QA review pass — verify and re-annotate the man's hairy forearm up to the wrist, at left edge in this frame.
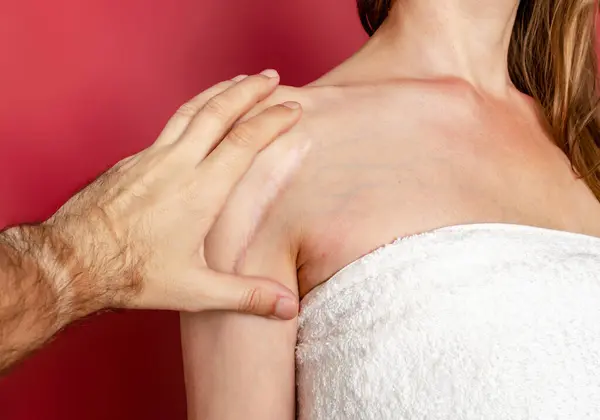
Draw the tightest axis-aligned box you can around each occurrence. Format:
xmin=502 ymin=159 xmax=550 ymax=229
xmin=0 ymin=224 xmax=106 ymax=373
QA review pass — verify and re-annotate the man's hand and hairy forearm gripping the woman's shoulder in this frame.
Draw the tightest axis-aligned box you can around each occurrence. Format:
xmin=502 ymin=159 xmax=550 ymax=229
xmin=0 ymin=71 xmax=306 ymax=370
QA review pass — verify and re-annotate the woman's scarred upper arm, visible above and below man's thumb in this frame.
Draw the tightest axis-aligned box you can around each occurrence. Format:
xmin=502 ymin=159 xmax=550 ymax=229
xmin=181 ymin=96 xmax=306 ymax=420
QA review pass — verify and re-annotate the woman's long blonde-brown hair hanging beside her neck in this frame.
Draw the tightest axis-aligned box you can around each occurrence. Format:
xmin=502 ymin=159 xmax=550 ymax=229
xmin=358 ymin=0 xmax=600 ymax=200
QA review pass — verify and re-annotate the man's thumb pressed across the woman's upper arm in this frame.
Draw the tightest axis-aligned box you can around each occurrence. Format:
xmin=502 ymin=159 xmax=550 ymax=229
xmin=202 ymin=270 xmax=298 ymax=320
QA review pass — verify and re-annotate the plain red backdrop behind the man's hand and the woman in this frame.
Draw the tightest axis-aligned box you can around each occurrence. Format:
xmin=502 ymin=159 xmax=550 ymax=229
xmin=0 ymin=0 xmax=365 ymax=420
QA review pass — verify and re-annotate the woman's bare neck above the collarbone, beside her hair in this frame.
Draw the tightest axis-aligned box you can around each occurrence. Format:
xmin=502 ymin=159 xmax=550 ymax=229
xmin=318 ymin=0 xmax=518 ymax=92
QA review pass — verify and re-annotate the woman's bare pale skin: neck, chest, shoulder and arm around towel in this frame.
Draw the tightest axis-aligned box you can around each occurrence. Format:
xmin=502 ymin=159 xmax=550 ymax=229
xmin=182 ymin=0 xmax=600 ymax=420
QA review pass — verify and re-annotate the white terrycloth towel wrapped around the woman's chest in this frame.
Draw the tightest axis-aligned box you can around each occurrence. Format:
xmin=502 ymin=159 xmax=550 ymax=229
xmin=296 ymin=224 xmax=600 ymax=420
